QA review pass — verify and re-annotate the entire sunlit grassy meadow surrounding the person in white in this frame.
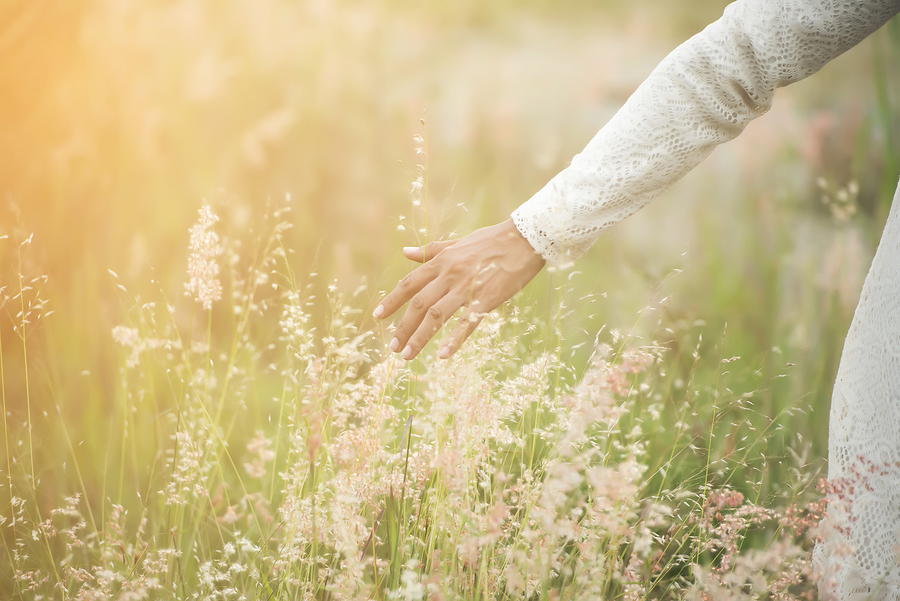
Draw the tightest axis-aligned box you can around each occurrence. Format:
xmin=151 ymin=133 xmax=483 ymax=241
xmin=0 ymin=0 xmax=900 ymax=600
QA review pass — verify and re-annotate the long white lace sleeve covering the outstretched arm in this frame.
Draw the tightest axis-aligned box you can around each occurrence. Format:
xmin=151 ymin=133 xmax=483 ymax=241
xmin=513 ymin=0 xmax=900 ymax=264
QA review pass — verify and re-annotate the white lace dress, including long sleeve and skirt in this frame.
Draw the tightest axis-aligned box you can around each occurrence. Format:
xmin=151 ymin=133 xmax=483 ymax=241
xmin=513 ymin=0 xmax=900 ymax=601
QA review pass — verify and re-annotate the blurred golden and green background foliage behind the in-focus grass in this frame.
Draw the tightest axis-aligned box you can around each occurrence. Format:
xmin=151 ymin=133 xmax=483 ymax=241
xmin=0 ymin=0 xmax=900 ymax=492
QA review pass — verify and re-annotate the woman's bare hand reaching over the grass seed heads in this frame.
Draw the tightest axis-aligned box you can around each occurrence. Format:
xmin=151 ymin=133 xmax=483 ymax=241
xmin=374 ymin=219 xmax=545 ymax=361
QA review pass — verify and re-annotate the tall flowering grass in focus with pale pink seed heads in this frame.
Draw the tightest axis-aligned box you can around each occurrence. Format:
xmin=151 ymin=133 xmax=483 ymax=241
xmin=0 ymin=206 xmax=818 ymax=599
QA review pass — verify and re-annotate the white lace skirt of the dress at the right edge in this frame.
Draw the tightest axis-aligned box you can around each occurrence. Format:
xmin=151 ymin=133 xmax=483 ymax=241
xmin=815 ymin=179 xmax=900 ymax=601
